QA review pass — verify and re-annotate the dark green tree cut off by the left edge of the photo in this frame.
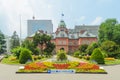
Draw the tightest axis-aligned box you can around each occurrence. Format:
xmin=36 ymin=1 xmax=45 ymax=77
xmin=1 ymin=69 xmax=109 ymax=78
xmin=0 ymin=31 xmax=6 ymax=54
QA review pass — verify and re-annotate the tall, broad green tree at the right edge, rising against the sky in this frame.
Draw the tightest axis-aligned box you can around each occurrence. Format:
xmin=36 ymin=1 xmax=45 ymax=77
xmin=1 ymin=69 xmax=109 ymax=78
xmin=98 ymin=19 xmax=120 ymax=44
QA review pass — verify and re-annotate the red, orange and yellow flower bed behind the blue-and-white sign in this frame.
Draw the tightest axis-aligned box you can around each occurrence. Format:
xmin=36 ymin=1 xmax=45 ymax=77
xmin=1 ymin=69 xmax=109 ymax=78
xmin=18 ymin=62 xmax=105 ymax=73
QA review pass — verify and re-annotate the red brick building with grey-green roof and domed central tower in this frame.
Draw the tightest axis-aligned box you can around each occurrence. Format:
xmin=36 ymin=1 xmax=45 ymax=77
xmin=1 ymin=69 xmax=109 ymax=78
xmin=28 ymin=20 xmax=97 ymax=52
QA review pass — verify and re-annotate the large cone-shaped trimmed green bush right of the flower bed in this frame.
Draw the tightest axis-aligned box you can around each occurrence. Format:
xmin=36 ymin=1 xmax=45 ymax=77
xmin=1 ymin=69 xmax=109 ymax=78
xmin=90 ymin=48 xmax=104 ymax=64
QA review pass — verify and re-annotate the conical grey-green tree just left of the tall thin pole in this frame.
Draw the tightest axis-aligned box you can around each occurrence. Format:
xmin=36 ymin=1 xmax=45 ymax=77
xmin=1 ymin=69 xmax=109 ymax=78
xmin=10 ymin=31 xmax=20 ymax=49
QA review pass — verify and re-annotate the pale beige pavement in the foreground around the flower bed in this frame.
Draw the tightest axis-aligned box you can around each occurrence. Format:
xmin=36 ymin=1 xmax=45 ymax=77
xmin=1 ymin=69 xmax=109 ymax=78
xmin=0 ymin=63 xmax=120 ymax=80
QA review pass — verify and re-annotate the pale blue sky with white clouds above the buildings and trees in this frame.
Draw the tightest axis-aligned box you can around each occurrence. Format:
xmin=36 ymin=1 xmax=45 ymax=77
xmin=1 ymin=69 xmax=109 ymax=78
xmin=0 ymin=0 xmax=120 ymax=38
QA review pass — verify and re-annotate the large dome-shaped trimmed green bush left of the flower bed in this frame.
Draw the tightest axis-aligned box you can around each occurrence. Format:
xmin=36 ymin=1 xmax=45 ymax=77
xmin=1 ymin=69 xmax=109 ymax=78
xmin=19 ymin=48 xmax=33 ymax=64
